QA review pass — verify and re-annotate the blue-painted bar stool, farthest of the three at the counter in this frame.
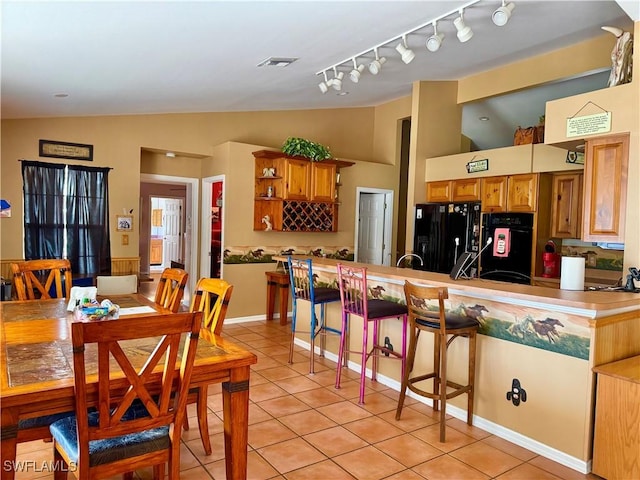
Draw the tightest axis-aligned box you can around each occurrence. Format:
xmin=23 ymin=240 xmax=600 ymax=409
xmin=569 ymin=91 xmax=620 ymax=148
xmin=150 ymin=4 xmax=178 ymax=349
xmin=285 ymin=257 xmax=341 ymax=374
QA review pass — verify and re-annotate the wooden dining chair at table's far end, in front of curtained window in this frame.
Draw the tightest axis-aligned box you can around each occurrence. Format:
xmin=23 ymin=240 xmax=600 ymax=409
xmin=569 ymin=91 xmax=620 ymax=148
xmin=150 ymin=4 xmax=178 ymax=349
xmin=11 ymin=258 xmax=72 ymax=300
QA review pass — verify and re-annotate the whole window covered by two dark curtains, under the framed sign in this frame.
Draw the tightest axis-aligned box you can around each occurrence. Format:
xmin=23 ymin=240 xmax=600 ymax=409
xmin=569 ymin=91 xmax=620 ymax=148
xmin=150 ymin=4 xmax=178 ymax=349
xmin=22 ymin=161 xmax=111 ymax=275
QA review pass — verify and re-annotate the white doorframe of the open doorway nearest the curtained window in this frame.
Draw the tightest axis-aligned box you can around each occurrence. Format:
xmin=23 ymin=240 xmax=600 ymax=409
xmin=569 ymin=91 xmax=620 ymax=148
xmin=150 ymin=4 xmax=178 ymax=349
xmin=140 ymin=173 xmax=200 ymax=305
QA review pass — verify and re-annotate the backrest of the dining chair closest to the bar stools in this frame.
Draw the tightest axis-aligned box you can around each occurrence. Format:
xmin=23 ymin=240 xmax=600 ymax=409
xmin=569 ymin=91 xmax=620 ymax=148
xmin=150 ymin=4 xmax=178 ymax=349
xmin=189 ymin=278 xmax=233 ymax=335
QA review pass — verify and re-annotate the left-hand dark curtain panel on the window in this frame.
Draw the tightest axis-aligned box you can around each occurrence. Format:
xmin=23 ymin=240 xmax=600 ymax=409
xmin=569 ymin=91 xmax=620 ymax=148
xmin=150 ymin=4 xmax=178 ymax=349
xmin=22 ymin=161 xmax=65 ymax=260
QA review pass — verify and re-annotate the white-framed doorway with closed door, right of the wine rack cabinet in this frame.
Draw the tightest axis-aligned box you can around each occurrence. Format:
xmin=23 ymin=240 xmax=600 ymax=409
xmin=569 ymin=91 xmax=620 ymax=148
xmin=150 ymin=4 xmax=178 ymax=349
xmin=355 ymin=187 xmax=393 ymax=266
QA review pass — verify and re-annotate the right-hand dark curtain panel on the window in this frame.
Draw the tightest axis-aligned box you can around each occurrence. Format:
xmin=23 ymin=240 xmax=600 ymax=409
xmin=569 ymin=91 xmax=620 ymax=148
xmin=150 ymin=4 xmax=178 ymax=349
xmin=66 ymin=165 xmax=111 ymax=275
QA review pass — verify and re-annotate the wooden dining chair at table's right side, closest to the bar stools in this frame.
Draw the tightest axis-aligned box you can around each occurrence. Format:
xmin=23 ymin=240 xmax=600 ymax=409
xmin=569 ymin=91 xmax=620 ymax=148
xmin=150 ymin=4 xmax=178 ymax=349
xmin=183 ymin=278 xmax=233 ymax=455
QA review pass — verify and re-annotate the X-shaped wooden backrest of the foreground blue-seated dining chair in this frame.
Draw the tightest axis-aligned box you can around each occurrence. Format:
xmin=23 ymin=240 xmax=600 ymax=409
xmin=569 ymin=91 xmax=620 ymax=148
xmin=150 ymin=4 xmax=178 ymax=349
xmin=71 ymin=312 xmax=202 ymax=444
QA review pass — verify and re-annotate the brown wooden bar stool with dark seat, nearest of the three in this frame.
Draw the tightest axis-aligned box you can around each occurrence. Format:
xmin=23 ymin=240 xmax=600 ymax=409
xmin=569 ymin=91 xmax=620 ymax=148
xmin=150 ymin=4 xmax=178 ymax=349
xmin=396 ymin=281 xmax=478 ymax=443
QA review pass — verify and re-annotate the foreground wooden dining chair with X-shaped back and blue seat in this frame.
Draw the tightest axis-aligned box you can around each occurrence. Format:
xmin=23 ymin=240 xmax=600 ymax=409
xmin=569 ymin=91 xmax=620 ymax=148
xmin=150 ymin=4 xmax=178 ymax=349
xmin=51 ymin=312 xmax=202 ymax=480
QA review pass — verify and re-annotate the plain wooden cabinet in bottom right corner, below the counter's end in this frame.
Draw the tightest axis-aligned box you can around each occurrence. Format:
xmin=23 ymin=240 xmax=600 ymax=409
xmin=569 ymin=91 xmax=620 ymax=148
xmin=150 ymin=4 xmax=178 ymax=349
xmin=592 ymin=356 xmax=640 ymax=479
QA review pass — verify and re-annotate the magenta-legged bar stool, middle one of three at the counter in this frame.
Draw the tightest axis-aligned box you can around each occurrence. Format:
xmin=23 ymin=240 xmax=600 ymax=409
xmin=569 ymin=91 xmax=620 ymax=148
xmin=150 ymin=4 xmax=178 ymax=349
xmin=336 ymin=263 xmax=407 ymax=404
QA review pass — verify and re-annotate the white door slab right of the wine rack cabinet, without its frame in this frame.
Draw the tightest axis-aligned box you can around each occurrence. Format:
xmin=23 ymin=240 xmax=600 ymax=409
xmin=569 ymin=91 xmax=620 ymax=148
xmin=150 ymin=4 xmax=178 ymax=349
xmin=358 ymin=193 xmax=385 ymax=265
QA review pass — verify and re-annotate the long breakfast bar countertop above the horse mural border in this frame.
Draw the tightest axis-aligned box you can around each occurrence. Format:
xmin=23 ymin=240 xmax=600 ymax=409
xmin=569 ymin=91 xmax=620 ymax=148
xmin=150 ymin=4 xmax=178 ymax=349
xmin=273 ymin=255 xmax=640 ymax=318
